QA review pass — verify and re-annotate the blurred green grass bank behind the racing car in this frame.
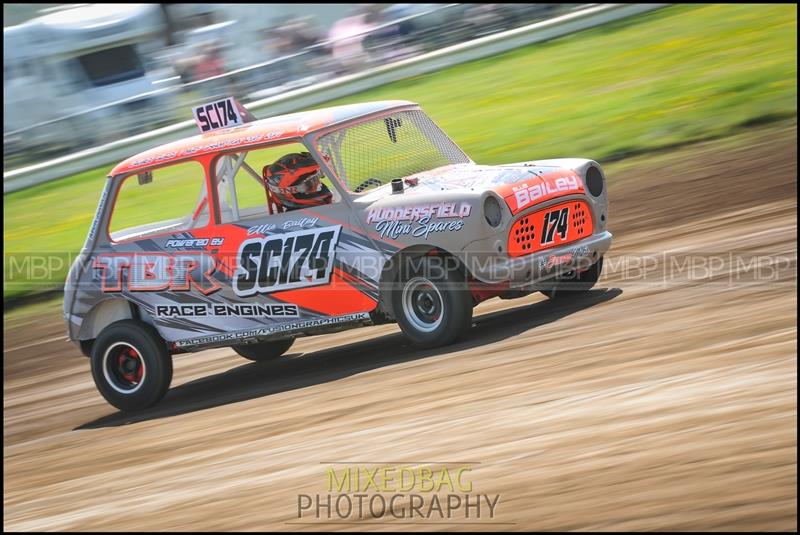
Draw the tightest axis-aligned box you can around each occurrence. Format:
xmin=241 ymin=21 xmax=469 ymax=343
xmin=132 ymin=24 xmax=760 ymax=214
xmin=4 ymin=5 xmax=797 ymax=299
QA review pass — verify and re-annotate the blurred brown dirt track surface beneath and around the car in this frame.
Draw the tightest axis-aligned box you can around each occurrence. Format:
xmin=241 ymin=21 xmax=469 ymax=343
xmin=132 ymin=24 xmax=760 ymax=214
xmin=3 ymin=125 xmax=797 ymax=530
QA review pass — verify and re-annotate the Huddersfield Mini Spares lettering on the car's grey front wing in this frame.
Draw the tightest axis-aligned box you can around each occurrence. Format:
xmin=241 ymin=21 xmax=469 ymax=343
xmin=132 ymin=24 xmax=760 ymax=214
xmin=367 ymin=202 xmax=472 ymax=239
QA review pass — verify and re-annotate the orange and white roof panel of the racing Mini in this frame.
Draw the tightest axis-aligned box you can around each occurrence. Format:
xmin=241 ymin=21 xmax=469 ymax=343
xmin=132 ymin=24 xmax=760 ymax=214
xmin=111 ymin=100 xmax=416 ymax=176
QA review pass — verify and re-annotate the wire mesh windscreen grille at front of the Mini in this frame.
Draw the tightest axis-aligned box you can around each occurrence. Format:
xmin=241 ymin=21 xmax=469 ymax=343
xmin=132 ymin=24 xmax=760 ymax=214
xmin=319 ymin=110 xmax=470 ymax=193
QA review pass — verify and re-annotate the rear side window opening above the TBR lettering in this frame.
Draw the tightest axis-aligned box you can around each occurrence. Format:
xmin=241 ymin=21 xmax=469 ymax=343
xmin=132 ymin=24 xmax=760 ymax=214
xmin=108 ymin=162 xmax=210 ymax=242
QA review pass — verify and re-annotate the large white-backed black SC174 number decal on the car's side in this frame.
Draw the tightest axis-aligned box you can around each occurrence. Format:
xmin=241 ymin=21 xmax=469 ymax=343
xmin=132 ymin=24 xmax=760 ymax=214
xmin=233 ymin=225 xmax=342 ymax=297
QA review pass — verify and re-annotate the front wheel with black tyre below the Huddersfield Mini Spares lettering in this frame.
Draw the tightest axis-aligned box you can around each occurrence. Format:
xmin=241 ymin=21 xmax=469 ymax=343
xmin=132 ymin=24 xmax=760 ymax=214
xmin=391 ymin=256 xmax=472 ymax=348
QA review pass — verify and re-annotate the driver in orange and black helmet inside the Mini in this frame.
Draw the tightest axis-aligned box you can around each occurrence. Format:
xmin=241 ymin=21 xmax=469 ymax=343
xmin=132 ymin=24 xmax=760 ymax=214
xmin=262 ymin=152 xmax=333 ymax=211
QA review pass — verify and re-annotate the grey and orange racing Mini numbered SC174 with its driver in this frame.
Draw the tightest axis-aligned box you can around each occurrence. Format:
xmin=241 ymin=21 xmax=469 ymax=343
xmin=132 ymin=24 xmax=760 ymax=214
xmin=64 ymin=98 xmax=612 ymax=410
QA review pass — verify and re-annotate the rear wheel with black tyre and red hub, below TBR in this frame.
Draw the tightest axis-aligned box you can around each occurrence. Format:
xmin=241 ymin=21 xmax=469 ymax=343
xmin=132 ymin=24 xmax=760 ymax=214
xmin=91 ymin=320 xmax=172 ymax=411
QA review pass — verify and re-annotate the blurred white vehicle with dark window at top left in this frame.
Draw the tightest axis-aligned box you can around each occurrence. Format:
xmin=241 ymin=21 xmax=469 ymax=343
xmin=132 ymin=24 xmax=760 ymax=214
xmin=3 ymin=4 xmax=179 ymax=152
